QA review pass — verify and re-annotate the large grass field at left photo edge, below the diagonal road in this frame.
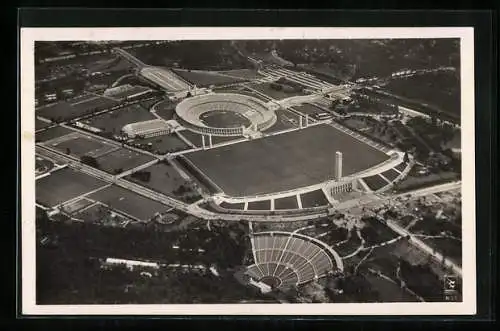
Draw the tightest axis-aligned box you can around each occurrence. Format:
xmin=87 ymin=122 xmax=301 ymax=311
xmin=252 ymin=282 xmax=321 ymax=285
xmin=36 ymin=168 xmax=106 ymax=207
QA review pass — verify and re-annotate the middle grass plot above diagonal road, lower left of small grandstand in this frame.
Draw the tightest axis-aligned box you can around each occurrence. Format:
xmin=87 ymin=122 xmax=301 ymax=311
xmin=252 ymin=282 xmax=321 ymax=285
xmin=97 ymin=148 xmax=153 ymax=174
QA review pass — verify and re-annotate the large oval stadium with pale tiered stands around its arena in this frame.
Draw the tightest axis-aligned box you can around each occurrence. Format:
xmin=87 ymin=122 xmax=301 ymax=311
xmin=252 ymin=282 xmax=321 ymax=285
xmin=175 ymin=93 xmax=277 ymax=136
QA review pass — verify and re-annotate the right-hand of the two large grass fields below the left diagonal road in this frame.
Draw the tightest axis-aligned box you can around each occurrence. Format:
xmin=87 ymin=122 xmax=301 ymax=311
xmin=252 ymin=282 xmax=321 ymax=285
xmin=89 ymin=185 xmax=170 ymax=220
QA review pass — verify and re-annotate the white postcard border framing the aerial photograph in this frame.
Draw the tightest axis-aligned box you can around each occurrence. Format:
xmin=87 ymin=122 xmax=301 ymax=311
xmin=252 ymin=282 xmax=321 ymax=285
xmin=18 ymin=27 xmax=476 ymax=315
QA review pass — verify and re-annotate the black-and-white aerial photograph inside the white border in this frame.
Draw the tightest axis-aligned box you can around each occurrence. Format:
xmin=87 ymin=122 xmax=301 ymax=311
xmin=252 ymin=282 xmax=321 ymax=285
xmin=33 ymin=36 xmax=463 ymax=307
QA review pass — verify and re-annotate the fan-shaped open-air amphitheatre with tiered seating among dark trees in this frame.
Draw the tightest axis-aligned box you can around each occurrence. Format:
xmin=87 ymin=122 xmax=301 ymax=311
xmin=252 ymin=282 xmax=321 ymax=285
xmin=246 ymin=231 xmax=343 ymax=290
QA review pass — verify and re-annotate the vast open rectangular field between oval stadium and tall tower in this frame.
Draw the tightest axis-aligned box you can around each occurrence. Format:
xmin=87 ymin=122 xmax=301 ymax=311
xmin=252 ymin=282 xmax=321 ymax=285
xmin=186 ymin=125 xmax=389 ymax=196
